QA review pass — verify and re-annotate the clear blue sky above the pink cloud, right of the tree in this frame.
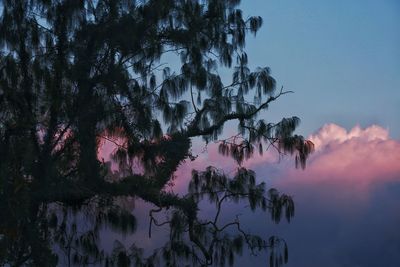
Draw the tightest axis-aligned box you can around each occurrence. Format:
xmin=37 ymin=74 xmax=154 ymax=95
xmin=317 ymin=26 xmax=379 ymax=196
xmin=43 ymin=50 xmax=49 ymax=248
xmin=242 ymin=0 xmax=400 ymax=139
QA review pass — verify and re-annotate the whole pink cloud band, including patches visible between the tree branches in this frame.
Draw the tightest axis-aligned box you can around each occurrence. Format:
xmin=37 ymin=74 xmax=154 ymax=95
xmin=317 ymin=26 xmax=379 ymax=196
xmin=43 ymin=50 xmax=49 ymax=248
xmin=101 ymin=123 xmax=400 ymax=201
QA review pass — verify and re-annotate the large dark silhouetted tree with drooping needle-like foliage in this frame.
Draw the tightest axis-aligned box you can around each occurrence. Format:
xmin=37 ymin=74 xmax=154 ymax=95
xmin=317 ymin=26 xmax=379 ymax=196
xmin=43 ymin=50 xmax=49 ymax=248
xmin=0 ymin=0 xmax=313 ymax=266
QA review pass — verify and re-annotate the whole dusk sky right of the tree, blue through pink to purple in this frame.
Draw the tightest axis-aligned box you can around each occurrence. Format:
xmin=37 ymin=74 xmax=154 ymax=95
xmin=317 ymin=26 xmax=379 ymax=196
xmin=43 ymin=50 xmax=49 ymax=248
xmin=101 ymin=0 xmax=400 ymax=267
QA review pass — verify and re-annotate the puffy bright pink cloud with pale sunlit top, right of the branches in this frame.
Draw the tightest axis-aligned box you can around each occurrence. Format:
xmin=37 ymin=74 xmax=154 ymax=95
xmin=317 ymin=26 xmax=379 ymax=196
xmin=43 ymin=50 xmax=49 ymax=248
xmin=281 ymin=124 xmax=400 ymax=194
